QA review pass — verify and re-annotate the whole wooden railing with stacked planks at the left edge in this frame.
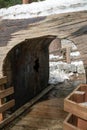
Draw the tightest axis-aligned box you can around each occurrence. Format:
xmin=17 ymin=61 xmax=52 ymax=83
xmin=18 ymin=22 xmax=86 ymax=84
xmin=0 ymin=77 xmax=15 ymax=122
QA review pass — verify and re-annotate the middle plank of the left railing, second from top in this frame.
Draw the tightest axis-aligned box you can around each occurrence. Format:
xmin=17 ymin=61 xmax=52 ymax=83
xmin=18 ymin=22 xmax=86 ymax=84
xmin=0 ymin=87 xmax=14 ymax=99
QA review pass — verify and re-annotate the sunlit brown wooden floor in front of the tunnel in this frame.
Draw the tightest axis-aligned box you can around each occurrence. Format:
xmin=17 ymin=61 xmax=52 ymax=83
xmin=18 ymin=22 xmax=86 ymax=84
xmin=6 ymin=98 xmax=67 ymax=130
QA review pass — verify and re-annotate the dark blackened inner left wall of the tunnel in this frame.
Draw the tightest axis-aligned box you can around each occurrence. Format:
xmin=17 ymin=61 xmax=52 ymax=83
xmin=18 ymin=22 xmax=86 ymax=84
xmin=3 ymin=36 xmax=55 ymax=111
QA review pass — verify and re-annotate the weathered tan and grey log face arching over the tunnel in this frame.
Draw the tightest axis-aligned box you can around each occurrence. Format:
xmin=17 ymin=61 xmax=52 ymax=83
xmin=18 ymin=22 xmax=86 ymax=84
xmin=0 ymin=11 xmax=87 ymax=76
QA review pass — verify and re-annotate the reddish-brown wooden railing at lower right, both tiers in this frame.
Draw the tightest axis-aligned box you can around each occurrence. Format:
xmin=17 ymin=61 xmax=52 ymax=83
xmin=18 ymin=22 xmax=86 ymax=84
xmin=64 ymin=84 xmax=87 ymax=130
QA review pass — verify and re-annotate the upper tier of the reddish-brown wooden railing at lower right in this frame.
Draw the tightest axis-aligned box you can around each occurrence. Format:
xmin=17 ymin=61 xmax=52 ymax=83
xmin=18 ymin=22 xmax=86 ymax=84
xmin=64 ymin=84 xmax=87 ymax=121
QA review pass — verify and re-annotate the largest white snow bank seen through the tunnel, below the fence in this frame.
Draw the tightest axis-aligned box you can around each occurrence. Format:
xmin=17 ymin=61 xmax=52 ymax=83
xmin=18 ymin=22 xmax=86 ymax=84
xmin=49 ymin=56 xmax=85 ymax=84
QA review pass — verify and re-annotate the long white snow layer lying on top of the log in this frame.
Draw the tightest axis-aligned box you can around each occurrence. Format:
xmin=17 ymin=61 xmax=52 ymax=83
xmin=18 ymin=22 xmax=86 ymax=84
xmin=0 ymin=0 xmax=87 ymax=19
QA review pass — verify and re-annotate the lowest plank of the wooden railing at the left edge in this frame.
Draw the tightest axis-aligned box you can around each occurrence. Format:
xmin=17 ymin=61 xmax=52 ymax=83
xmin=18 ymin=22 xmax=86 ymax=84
xmin=0 ymin=99 xmax=15 ymax=113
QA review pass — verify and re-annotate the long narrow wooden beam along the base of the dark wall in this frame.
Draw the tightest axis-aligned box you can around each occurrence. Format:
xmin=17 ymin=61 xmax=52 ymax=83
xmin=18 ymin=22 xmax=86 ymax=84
xmin=0 ymin=85 xmax=54 ymax=129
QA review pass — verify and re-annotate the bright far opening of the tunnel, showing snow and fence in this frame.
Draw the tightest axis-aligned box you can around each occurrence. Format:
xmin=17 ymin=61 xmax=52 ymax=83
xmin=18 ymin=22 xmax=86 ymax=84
xmin=49 ymin=39 xmax=86 ymax=97
